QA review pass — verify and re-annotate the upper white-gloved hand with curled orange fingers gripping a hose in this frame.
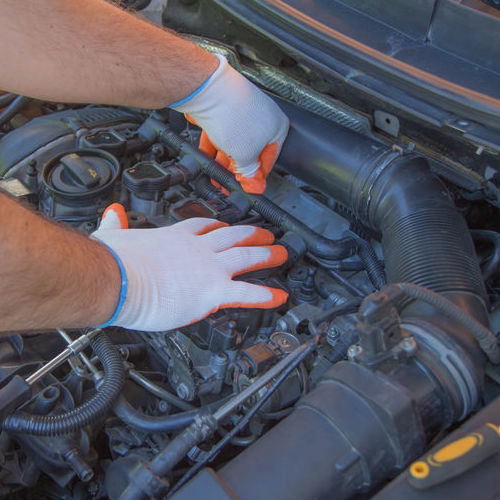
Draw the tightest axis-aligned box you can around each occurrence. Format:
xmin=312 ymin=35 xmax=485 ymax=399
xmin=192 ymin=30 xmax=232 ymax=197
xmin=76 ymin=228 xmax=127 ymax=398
xmin=170 ymin=55 xmax=288 ymax=194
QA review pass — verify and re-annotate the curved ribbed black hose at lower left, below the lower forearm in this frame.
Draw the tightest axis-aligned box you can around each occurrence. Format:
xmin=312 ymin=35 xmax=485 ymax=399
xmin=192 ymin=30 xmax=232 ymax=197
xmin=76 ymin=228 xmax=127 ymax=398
xmin=2 ymin=333 xmax=125 ymax=436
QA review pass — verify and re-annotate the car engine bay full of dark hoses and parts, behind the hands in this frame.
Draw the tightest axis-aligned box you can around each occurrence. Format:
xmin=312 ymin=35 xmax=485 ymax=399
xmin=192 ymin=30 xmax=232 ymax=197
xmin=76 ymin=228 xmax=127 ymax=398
xmin=0 ymin=2 xmax=500 ymax=500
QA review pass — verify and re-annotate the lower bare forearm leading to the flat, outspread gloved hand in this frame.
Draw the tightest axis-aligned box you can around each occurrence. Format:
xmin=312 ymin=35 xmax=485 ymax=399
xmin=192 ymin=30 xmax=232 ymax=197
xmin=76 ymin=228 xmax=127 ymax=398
xmin=0 ymin=193 xmax=120 ymax=331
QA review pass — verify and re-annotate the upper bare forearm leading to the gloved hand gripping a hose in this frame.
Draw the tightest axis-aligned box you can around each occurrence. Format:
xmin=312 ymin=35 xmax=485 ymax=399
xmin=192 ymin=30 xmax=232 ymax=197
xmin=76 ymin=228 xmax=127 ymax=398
xmin=0 ymin=0 xmax=217 ymax=108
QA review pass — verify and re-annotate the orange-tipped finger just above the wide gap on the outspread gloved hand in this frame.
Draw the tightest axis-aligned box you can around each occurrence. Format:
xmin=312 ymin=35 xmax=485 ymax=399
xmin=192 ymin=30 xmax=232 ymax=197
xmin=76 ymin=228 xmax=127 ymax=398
xmin=218 ymin=245 xmax=288 ymax=278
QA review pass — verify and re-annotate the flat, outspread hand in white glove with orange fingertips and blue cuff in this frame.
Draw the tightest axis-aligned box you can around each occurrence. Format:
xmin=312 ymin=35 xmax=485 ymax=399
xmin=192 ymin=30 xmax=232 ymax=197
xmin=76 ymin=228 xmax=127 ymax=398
xmin=92 ymin=203 xmax=288 ymax=331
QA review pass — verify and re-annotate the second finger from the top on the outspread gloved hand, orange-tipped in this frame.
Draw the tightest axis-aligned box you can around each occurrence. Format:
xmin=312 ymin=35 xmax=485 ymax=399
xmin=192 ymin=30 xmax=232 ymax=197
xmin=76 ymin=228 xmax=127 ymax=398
xmin=203 ymin=226 xmax=274 ymax=252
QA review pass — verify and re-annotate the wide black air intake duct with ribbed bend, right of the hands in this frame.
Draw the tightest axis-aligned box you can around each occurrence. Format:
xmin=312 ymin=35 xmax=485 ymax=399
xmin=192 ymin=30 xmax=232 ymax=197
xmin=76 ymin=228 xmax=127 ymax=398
xmin=280 ymin=102 xmax=486 ymax=322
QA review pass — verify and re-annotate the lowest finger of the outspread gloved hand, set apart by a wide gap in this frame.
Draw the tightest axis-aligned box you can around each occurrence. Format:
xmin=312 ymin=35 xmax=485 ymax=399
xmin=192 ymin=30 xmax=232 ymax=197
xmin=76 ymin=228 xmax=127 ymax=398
xmin=218 ymin=281 xmax=288 ymax=309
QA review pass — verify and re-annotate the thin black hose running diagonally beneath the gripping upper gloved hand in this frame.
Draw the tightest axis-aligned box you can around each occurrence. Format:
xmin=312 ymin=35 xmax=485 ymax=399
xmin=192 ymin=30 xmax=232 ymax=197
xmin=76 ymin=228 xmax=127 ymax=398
xmin=156 ymin=123 xmax=357 ymax=260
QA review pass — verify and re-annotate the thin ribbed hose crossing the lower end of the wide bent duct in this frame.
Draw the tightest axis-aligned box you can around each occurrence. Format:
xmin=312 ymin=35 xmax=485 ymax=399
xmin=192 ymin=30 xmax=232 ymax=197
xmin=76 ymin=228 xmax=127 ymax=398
xmin=387 ymin=283 xmax=500 ymax=364
